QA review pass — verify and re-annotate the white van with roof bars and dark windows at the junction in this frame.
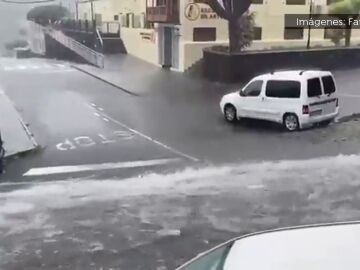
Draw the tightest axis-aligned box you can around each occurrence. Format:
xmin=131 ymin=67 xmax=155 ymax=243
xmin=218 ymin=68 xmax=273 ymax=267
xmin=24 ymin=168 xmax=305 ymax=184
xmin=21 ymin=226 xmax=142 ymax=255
xmin=220 ymin=70 xmax=339 ymax=131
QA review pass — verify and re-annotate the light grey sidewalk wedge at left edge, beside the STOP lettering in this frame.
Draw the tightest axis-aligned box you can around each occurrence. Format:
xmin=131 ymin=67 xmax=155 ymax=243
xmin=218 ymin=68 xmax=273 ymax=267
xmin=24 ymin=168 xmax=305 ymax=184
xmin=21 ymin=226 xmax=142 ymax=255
xmin=0 ymin=89 xmax=38 ymax=157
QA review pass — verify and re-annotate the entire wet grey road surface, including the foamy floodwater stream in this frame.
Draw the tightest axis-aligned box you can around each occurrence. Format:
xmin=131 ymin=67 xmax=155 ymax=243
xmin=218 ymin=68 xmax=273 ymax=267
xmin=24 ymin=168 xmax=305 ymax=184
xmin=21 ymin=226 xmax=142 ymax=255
xmin=0 ymin=60 xmax=360 ymax=270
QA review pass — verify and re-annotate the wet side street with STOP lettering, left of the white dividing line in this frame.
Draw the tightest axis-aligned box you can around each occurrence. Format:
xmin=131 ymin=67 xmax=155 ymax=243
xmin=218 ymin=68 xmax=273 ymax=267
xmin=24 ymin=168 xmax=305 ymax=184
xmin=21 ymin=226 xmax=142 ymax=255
xmin=1 ymin=60 xmax=197 ymax=181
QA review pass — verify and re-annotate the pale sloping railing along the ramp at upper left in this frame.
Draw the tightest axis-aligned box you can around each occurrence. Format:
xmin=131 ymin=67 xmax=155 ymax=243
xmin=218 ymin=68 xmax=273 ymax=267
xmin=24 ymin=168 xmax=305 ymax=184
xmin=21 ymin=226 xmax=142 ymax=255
xmin=46 ymin=27 xmax=104 ymax=68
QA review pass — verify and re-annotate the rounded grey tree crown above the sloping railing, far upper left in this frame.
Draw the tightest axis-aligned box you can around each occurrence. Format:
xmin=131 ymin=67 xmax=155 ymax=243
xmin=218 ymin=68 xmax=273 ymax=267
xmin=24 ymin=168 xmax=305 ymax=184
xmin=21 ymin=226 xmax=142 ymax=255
xmin=26 ymin=5 xmax=70 ymax=25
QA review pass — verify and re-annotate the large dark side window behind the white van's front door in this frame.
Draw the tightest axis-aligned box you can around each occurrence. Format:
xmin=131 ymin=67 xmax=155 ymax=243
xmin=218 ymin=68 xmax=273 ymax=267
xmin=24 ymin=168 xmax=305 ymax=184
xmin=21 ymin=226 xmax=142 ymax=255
xmin=266 ymin=80 xmax=301 ymax=98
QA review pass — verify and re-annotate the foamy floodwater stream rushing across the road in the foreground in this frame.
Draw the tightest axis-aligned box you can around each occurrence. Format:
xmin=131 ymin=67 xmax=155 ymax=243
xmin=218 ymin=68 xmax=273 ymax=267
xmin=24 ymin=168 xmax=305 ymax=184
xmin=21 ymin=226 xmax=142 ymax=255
xmin=0 ymin=156 xmax=360 ymax=270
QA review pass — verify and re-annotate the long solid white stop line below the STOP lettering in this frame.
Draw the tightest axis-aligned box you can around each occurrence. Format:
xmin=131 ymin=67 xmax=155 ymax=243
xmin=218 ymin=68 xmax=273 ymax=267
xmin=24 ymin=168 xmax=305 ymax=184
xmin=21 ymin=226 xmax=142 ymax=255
xmin=24 ymin=158 xmax=181 ymax=176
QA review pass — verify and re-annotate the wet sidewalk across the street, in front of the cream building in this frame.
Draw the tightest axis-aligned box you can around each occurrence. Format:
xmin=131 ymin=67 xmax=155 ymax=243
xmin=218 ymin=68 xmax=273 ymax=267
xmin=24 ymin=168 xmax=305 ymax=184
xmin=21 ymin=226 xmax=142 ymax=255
xmin=73 ymin=54 xmax=238 ymax=96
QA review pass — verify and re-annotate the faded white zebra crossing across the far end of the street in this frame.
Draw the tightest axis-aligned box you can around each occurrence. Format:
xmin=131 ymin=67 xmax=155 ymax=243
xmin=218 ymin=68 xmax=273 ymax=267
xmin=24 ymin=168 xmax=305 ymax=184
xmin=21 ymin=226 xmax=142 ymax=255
xmin=0 ymin=60 xmax=74 ymax=73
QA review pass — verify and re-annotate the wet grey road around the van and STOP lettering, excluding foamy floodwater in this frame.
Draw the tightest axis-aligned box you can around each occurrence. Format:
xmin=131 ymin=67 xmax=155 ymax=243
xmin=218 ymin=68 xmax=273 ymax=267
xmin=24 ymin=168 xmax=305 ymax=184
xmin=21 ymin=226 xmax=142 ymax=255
xmin=0 ymin=59 xmax=360 ymax=180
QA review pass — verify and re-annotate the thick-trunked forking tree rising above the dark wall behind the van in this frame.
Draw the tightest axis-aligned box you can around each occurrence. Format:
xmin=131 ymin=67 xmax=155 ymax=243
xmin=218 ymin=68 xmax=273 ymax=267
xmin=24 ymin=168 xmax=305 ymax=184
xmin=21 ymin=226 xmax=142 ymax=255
xmin=205 ymin=0 xmax=251 ymax=53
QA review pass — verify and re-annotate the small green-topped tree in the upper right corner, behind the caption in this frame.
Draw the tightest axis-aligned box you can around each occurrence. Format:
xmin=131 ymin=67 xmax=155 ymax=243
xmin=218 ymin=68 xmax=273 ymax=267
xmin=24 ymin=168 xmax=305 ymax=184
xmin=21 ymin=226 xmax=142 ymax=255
xmin=329 ymin=0 xmax=360 ymax=46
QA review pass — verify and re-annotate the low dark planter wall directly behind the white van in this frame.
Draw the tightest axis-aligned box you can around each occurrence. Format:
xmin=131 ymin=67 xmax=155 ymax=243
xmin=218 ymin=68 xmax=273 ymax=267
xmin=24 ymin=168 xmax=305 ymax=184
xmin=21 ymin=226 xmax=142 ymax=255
xmin=203 ymin=48 xmax=360 ymax=82
